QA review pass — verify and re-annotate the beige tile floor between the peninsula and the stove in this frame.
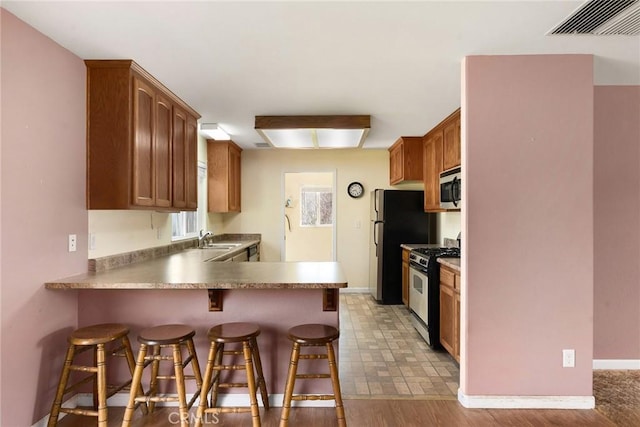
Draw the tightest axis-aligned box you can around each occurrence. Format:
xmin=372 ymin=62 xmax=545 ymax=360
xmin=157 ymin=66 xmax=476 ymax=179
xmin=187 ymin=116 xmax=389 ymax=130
xmin=339 ymin=294 xmax=460 ymax=399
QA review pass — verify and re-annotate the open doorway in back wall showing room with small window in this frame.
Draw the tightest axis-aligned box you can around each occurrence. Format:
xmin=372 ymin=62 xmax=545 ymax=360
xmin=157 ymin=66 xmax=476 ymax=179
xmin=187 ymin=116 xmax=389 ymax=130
xmin=281 ymin=172 xmax=336 ymax=261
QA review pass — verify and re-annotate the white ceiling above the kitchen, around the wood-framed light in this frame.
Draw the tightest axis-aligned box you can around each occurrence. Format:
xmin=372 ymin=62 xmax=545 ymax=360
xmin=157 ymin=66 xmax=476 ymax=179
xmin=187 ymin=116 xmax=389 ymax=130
xmin=2 ymin=0 xmax=640 ymax=148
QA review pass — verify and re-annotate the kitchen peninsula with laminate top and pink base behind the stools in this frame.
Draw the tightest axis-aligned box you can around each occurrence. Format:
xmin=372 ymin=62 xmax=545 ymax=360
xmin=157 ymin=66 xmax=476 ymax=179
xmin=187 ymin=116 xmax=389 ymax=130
xmin=45 ymin=248 xmax=347 ymax=406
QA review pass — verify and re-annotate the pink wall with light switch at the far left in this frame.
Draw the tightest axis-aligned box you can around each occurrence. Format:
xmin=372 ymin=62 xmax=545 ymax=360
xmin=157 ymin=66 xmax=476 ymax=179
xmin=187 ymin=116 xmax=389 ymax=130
xmin=0 ymin=9 xmax=87 ymax=426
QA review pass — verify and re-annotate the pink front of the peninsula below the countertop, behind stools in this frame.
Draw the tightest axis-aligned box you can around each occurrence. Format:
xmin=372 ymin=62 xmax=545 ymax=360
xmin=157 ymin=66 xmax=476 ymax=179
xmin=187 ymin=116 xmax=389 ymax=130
xmin=78 ymin=289 xmax=339 ymax=396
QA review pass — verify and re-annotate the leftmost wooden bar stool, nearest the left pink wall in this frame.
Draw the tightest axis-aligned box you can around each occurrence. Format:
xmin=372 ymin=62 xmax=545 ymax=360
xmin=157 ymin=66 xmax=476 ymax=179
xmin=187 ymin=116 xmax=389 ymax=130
xmin=47 ymin=323 xmax=147 ymax=427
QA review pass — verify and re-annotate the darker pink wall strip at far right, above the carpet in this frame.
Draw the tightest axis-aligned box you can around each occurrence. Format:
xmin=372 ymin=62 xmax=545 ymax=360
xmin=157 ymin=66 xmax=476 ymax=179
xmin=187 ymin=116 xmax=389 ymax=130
xmin=593 ymin=86 xmax=640 ymax=360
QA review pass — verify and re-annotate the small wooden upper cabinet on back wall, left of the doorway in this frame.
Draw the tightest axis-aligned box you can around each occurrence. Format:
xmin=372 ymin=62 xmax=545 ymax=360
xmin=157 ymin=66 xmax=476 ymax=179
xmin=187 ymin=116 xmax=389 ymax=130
xmin=207 ymin=140 xmax=242 ymax=212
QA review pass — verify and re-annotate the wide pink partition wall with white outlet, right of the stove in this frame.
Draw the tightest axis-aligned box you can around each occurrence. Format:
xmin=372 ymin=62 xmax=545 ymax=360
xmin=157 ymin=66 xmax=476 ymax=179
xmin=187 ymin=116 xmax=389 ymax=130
xmin=461 ymin=55 xmax=593 ymax=396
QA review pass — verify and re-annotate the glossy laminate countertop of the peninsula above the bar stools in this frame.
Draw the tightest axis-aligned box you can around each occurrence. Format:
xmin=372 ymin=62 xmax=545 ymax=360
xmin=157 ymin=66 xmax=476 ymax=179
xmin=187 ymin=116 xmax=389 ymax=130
xmin=45 ymin=249 xmax=347 ymax=289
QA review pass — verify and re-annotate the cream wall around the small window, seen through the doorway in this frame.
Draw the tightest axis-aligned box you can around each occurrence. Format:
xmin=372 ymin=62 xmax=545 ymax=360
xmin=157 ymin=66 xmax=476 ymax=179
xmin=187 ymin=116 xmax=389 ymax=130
xmin=280 ymin=172 xmax=333 ymax=261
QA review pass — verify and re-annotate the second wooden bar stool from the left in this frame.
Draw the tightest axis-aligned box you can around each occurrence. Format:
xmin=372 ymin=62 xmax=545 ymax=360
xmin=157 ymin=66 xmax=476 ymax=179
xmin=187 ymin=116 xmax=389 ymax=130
xmin=122 ymin=325 xmax=202 ymax=427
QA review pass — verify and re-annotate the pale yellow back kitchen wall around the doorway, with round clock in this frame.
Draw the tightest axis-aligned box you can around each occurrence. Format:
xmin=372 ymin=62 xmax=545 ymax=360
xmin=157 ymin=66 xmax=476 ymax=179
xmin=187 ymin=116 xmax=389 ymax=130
xmin=216 ymin=150 xmax=389 ymax=287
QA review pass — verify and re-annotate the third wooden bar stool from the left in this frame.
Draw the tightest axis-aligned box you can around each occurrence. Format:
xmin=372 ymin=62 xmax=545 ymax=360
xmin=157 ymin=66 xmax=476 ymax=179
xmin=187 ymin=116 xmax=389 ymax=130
xmin=195 ymin=322 xmax=269 ymax=427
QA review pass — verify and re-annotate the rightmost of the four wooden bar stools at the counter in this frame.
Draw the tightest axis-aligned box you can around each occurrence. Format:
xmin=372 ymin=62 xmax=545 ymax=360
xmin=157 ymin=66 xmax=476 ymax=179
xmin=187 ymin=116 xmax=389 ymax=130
xmin=280 ymin=324 xmax=347 ymax=427
